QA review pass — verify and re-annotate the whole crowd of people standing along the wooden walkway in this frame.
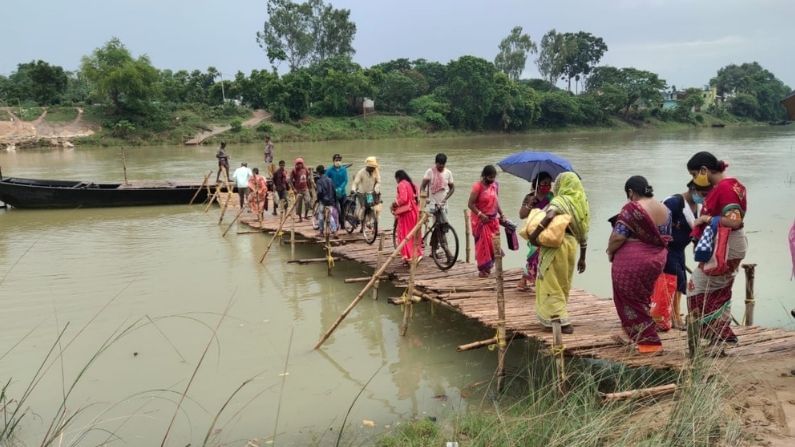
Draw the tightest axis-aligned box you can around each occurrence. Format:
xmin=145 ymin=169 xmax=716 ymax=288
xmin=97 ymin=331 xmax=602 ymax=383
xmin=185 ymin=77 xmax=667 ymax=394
xmin=216 ymin=139 xmax=747 ymax=354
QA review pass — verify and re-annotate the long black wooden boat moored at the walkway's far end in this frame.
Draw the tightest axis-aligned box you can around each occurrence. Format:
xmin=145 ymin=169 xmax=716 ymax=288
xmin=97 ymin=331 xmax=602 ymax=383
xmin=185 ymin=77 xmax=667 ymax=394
xmin=0 ymin=177 xmax=222 ymax=208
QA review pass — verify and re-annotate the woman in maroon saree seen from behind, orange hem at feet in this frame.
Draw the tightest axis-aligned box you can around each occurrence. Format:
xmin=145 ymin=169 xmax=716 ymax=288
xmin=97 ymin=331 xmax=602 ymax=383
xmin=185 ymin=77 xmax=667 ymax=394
xmin=607 ymin=175 xmax=671 ymax=353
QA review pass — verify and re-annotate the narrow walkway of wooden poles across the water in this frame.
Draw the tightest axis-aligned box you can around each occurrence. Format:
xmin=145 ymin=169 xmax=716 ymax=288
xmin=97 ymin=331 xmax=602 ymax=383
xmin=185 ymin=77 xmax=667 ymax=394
xmin=218 ymin=195 xmax=795 ymax=369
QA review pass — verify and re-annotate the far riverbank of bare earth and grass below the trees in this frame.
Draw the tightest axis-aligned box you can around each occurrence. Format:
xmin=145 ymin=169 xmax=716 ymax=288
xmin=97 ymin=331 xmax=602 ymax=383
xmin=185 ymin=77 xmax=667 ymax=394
xmin=0 ymin=106 xmax=766 ymax=149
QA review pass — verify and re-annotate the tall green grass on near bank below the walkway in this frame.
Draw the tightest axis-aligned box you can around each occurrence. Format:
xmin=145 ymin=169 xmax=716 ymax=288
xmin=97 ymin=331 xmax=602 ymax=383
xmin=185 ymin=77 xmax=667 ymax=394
xmin=378 ymin=342 xmax=742 ymax=447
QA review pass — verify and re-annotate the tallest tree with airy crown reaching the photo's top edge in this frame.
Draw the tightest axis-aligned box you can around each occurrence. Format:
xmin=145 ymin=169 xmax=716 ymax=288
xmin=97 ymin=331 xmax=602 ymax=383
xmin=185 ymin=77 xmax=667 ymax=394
xmin=257 ymin=0 xmax=356 ymax=71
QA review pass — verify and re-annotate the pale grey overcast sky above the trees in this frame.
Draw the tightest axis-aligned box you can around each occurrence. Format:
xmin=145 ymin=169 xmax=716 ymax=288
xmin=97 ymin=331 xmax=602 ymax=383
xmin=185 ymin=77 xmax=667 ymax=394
xmin=0 ymin=0 xmax=795 ymax=88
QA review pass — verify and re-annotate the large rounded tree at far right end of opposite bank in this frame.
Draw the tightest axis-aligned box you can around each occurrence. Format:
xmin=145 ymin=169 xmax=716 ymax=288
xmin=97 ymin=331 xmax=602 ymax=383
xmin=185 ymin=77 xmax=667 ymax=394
xmin=710 ymin=62 xmax=790 ymax=120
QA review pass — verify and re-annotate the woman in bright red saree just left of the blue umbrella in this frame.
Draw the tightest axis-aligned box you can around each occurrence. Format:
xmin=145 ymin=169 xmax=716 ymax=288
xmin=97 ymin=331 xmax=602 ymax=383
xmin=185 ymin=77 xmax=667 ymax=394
xmin=468 ymin=165 xmax=503 ymax=278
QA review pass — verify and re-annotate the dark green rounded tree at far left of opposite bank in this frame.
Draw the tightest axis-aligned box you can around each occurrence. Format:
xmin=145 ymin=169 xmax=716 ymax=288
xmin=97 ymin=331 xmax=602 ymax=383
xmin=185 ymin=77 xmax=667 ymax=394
xmin=8 ymin=60 xmax=68 ymax=105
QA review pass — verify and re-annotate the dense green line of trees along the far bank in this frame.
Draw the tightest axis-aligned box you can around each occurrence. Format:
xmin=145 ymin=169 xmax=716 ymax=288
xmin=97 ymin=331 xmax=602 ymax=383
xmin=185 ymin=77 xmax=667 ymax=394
xmin=0 ymin=21 xmax=789 ymax=138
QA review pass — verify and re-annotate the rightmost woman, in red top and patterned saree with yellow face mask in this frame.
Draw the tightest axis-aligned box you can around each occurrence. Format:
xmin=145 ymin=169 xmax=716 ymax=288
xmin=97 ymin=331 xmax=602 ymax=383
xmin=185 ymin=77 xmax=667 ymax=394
xmin=687 ymin=152 xmax=748 ymax=345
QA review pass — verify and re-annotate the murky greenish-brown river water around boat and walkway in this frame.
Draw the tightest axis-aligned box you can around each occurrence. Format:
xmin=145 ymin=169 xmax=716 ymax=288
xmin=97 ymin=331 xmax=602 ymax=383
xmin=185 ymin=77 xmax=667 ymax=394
xmin=0 ymin=127 xmax=795 ymax=445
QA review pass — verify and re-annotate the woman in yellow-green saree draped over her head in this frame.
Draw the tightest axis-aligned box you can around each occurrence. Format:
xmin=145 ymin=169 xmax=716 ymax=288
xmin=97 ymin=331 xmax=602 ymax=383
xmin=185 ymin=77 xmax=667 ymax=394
xmin=528 ymin=172 xmax=591 ymax=334
